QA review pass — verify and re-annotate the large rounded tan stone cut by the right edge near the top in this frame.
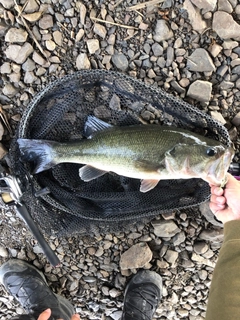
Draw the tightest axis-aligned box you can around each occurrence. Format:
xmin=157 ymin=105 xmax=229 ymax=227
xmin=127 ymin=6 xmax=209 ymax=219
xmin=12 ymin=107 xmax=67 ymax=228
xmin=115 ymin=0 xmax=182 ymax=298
xmin=212 ymin=11 xmax=240 ymax=41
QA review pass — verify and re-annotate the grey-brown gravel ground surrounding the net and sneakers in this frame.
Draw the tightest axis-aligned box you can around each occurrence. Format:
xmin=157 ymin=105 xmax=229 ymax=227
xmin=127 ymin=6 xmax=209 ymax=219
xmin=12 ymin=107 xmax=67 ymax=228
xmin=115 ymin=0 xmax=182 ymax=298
xmin=0 ymin=0 xmax=240 ymax=320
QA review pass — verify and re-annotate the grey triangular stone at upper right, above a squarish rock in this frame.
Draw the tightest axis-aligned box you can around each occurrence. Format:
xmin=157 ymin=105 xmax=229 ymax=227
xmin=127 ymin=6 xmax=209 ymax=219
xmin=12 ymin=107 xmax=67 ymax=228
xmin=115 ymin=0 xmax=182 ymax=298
xmin=187 ymin=48 xmax=216 ymax=72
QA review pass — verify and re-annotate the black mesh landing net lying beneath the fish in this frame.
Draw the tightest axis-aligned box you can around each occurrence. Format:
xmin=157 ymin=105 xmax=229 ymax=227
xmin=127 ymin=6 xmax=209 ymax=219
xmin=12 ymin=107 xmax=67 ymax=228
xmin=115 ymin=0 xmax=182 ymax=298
xmin=10 ymin=70 xmax=231 ymax=236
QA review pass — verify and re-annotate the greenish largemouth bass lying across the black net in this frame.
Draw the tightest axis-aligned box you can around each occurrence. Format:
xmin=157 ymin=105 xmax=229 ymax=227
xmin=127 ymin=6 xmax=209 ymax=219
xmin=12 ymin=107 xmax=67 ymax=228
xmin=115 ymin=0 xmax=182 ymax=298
xmin=18 ymin=116 xmax=234 ymax=192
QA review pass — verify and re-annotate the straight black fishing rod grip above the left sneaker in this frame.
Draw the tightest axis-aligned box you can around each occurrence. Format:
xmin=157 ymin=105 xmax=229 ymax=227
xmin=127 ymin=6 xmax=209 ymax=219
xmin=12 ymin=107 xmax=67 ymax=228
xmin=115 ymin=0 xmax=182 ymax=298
xmin=16 ymin=205 xmax=60 ymax=267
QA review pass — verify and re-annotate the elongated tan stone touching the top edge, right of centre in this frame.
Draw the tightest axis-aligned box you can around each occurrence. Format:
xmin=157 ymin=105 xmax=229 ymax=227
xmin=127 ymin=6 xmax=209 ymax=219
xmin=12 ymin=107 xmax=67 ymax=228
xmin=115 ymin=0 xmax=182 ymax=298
xmin=183 ymin=0 xmax=207 ymax=32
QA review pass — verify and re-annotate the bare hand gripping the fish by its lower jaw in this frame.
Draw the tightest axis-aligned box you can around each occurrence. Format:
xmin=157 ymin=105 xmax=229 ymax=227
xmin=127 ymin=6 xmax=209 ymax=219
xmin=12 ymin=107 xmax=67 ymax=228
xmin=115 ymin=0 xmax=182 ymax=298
xmin=209 ymin=173 xmax=240 ymax=223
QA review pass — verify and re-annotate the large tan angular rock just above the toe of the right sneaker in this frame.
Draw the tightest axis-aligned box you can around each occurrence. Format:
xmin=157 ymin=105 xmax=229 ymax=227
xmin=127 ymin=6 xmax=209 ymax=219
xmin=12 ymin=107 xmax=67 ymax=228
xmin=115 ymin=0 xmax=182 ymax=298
xmin=120 ymin=242 xmax=152 ymax=270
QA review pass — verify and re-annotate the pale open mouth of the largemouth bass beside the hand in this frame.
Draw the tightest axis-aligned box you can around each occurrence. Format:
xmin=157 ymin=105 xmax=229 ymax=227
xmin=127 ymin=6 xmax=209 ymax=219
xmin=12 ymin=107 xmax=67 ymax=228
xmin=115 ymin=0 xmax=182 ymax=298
xmin=207 ymin=147 xmax=234 ymax=186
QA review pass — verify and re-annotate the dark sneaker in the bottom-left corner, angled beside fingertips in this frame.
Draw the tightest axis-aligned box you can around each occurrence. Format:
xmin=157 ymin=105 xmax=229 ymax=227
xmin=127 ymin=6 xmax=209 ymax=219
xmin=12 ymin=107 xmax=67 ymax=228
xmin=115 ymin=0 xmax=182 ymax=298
xmin=0 ymin=259 xmax=74 ymax=320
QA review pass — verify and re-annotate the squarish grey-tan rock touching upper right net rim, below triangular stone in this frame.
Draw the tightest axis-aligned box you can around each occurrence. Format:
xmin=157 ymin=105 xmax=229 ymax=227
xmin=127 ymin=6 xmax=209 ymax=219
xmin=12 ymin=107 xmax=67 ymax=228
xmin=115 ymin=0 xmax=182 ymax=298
xmin=187 ymin=80 xmax=212 ymax=102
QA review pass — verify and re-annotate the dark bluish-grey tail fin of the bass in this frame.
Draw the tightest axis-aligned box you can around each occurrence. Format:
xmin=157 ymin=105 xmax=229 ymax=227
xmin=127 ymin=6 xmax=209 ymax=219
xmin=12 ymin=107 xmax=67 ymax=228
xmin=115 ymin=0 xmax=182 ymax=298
xmin=17 ymin=139 xmax=56 ymax=174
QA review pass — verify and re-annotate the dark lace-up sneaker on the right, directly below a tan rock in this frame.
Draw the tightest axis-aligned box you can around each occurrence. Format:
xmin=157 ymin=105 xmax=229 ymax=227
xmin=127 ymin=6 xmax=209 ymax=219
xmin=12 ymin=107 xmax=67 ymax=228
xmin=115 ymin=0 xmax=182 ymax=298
xmin=122 ymin=270 xmax=162 ymax=320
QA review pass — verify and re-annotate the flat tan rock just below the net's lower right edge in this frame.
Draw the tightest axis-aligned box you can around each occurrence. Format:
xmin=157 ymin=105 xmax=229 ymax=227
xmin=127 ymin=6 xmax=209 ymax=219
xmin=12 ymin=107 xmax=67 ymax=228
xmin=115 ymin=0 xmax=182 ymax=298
xmin=152 ymin=220 xmax=180 ymax=238
